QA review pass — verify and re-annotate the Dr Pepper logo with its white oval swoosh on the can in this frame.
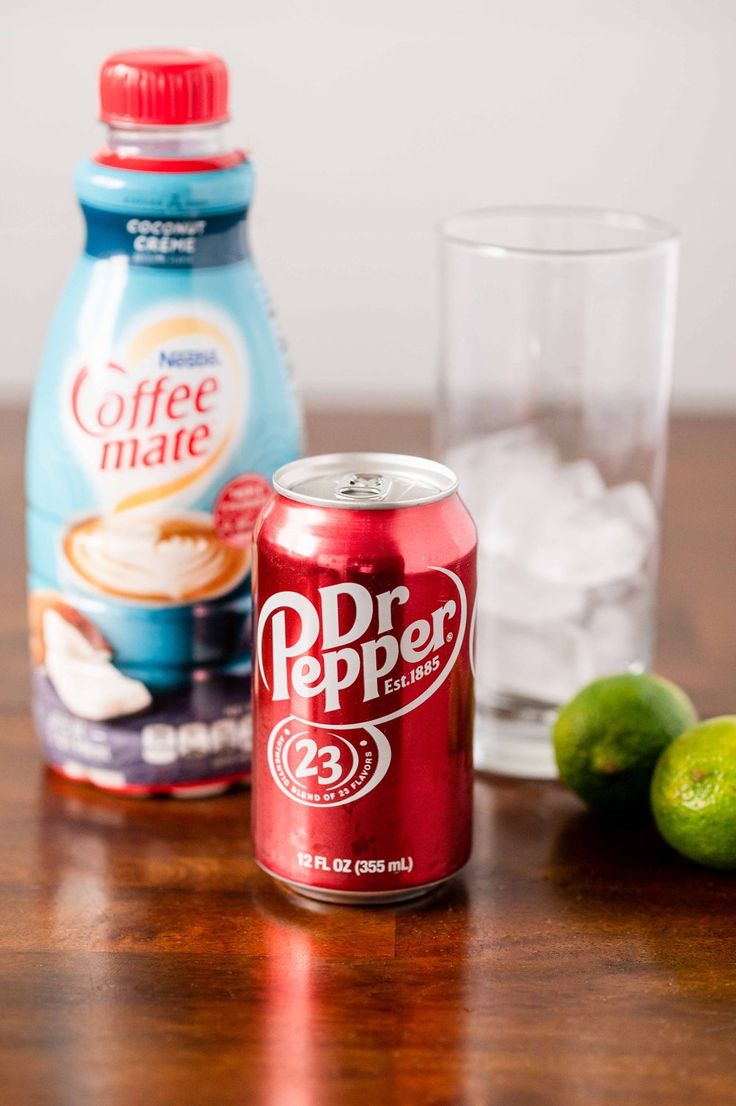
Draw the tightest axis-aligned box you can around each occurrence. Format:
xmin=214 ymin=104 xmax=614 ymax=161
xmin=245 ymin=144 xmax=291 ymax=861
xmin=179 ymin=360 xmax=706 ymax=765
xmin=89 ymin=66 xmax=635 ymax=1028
xmin=257 ymin=567 xmax=467 ymax=729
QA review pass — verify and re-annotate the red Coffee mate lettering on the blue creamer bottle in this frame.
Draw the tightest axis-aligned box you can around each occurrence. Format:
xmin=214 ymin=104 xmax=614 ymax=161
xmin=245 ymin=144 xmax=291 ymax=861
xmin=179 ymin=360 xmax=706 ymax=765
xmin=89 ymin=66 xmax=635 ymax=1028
xmin=71 ymin=354 xmax=220 ymax=471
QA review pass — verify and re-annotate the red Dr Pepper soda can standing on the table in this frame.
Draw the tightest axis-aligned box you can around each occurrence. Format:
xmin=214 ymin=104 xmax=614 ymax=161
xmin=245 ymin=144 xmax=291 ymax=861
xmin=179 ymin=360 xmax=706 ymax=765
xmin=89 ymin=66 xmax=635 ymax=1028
xmin=252 ymin=453 xmax=476 ymax=904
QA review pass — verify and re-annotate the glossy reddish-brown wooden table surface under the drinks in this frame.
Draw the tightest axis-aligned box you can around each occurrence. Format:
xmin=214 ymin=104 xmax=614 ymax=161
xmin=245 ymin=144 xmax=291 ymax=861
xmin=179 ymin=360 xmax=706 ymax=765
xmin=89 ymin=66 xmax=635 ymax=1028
xmin=0 ymin=411 xmax=736 ymax=1106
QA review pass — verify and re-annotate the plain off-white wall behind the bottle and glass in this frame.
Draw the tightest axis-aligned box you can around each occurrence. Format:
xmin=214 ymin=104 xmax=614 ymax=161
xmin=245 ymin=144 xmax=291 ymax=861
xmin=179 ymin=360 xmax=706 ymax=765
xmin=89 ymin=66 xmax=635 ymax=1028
xmin=0 ymin=0 xmax=736 ymax=408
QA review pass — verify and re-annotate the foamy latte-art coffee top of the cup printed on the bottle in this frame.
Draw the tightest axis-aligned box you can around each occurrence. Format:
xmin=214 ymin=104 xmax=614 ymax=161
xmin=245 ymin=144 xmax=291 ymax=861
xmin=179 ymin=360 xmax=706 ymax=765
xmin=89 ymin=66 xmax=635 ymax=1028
xmin=58 ymin=510 xmax=250 ymax=607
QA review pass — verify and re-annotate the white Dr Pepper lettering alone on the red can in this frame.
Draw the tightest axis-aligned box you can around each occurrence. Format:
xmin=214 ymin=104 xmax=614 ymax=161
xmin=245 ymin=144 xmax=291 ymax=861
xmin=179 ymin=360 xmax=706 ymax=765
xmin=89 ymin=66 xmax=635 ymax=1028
xmin=258 ymin=583 xmax=458 ymax=711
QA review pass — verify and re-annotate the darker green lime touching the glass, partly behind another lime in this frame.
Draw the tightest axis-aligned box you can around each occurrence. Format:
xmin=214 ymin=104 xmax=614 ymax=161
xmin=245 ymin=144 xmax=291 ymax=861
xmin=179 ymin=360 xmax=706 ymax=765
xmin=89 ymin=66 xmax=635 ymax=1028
xmin=552 ymin=674 xmax=697 ymax=812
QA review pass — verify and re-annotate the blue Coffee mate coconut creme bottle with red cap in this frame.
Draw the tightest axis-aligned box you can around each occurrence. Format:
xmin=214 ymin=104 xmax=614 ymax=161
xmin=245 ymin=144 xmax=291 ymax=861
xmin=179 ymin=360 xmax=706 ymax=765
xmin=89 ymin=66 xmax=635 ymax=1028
xmin=27 ymin=51 xmax=299 ymax=796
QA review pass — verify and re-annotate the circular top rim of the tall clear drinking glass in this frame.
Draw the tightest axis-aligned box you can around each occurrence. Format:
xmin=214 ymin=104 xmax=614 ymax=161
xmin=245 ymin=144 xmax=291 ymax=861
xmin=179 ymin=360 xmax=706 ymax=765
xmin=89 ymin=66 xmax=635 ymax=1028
xmin=437 ymin=204 xmax=680 ymax=258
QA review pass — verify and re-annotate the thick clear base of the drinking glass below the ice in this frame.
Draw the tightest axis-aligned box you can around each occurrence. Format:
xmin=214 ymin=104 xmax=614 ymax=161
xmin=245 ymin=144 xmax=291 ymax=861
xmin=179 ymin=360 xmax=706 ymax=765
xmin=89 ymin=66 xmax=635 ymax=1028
xmin=474 ymin=703 xmax=557 ymax=780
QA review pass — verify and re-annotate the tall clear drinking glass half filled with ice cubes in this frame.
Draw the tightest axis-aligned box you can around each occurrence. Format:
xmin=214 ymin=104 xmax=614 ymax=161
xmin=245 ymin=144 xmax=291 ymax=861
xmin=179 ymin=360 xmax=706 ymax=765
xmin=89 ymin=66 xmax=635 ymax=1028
xmin=436 ymin=207 xmax=678 ymax=778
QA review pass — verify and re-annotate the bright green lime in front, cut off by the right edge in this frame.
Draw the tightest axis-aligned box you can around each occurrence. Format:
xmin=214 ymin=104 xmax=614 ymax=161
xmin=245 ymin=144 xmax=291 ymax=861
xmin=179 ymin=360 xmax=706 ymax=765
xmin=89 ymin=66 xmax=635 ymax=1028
xmin=652 ymin=714 xmax=736 ymax=868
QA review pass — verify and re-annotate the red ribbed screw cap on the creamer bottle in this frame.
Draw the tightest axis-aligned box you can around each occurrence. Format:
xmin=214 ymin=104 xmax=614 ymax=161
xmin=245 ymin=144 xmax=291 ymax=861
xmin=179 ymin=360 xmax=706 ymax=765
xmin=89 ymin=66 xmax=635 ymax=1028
xmin=100 ymin=50 xmax=228 ymax=126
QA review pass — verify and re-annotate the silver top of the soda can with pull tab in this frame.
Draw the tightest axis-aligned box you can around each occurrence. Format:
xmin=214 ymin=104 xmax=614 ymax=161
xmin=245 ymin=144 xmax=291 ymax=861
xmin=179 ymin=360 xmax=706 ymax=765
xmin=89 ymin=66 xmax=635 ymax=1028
xmin=273 ymin=453 xmax=457 ymax=511
